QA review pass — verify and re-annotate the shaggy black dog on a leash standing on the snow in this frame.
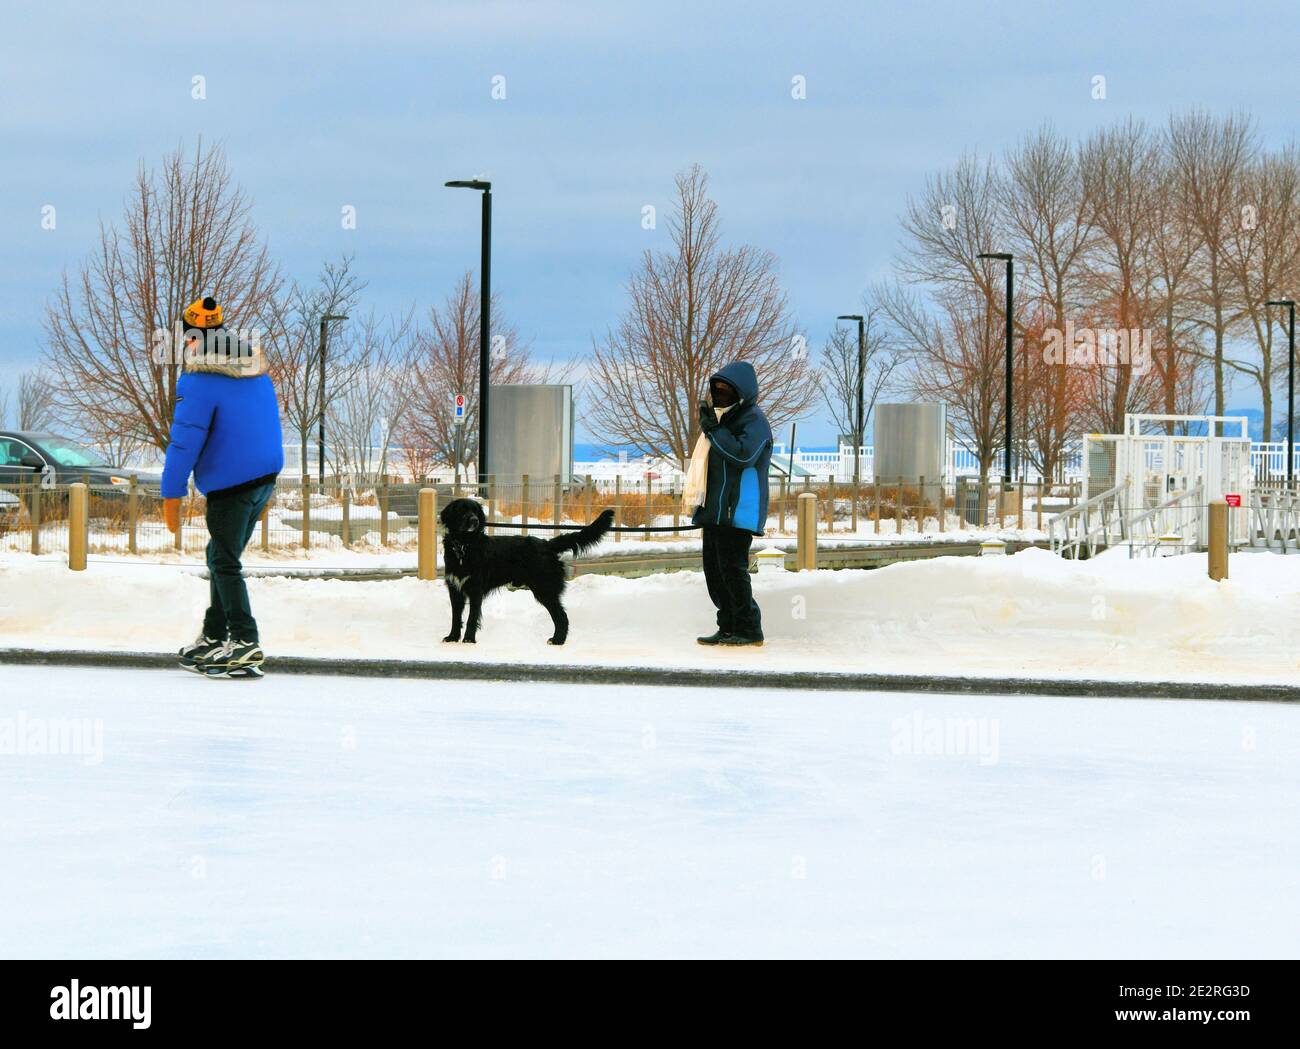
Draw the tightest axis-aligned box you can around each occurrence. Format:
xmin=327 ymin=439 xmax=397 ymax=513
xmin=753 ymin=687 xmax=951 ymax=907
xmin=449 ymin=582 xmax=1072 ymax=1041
xmin=438 ymin=499 xmax=614 ymax=645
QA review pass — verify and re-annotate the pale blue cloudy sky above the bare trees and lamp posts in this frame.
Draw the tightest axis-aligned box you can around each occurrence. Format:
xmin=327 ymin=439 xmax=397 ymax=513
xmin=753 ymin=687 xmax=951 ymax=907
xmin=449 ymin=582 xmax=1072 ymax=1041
xmin=0 ymin=0 xmax=1300 ymax=443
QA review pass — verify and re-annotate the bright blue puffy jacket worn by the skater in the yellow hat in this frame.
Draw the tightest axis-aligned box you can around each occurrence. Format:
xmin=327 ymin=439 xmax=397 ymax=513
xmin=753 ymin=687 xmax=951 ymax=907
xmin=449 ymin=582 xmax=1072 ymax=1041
xmin=163 ymin=354 xmax=285 ymax=499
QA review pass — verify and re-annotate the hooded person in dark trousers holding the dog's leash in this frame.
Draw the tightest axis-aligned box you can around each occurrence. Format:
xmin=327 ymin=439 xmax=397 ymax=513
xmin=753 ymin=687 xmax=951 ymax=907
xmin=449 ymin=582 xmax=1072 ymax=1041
xmin=692 ymin=360 xmax=772 ymax=645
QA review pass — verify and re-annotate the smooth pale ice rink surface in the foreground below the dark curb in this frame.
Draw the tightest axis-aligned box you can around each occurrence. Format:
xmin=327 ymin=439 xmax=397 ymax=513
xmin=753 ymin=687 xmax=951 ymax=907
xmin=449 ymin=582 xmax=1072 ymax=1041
xmin=0 ymin=667 xmax=1300 ymax=957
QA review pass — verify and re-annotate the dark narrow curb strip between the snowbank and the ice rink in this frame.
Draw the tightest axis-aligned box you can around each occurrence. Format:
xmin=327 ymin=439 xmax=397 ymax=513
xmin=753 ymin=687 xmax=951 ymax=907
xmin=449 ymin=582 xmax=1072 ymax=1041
xmin=0 ymin=649 xmax=1300 ymax=703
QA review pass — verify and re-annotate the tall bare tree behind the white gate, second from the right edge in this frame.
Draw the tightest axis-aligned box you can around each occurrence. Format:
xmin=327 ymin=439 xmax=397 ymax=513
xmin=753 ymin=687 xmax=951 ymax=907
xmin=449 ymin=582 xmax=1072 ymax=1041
xmin=1165 ymin=110 xmax=1258 ymax=415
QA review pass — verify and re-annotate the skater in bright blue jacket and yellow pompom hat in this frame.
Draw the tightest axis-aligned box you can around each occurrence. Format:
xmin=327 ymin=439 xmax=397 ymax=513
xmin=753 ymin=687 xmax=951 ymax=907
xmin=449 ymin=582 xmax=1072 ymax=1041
xmin=163 ymin=298 xmax=285 ymax=677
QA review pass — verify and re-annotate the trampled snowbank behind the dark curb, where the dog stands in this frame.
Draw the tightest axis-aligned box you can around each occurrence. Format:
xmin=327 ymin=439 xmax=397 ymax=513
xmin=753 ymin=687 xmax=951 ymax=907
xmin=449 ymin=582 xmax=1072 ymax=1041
xmin=0 ymin=543 xmax=1300 ymax=684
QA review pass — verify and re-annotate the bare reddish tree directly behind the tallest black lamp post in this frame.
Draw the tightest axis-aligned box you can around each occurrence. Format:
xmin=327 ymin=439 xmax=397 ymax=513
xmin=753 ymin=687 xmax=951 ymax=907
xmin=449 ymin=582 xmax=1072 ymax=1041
xmin=399 ymin=272 xmax=551 ymax=480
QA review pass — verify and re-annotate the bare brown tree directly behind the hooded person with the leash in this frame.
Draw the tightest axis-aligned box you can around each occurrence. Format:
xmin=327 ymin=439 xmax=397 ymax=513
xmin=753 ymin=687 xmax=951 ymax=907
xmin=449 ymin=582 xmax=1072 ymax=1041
xmin=586 ymin=164 xmax=818 ymax=463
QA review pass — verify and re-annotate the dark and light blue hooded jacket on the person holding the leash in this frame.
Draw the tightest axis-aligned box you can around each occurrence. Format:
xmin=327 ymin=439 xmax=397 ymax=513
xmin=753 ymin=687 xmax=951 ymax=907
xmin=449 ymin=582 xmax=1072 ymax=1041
xmin=692 ymin=360 xmax=772 ymax=536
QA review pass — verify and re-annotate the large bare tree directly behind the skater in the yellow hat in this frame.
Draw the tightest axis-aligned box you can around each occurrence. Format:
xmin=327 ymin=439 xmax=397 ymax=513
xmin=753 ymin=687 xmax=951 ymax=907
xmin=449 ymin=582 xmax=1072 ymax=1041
xmin=43 ymin=142 xmax=280 ymax=450
